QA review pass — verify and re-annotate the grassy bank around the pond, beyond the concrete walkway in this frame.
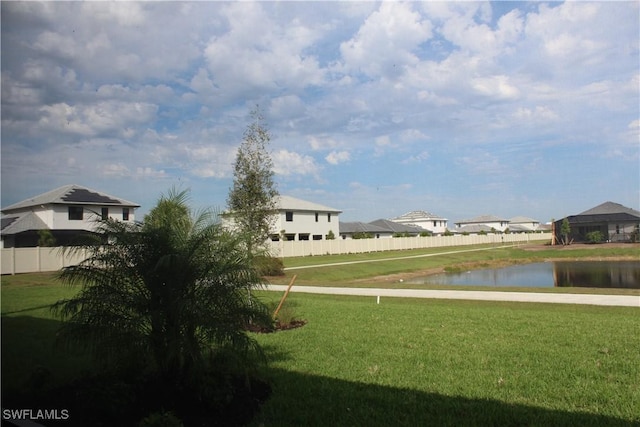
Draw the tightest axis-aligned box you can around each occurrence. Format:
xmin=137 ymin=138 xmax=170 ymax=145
xmin=270 ymin=244 xmax=640 ymax=295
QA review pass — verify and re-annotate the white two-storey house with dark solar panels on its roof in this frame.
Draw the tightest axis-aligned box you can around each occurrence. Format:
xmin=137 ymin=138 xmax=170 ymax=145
xmin=0 ymin=185 xmax=140 ymax=248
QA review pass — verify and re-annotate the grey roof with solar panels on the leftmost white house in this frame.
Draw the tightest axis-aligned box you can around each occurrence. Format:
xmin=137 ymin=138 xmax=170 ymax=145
xmin=2 ymin=184 xmax=140 ymax=212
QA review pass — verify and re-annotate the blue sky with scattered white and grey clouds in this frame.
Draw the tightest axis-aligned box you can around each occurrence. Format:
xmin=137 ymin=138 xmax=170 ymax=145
xmin=0 ymin=1 xmax=640 ymax=224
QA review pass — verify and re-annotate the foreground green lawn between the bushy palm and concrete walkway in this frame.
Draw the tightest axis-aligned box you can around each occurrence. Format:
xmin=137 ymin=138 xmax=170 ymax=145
xmin=254 ymin=294 xmax=640 ymax=426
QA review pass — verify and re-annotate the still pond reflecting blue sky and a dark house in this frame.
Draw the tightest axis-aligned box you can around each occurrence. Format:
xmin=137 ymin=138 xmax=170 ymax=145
xmin=407 ymin=261 xmax=640 ymax=289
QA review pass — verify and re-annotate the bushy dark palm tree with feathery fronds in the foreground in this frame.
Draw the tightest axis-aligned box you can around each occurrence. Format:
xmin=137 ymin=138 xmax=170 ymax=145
xmin=54 ymin=190 xmax=271 ymax=392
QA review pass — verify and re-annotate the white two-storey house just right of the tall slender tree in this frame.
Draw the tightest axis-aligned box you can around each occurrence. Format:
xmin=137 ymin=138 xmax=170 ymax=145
xmin=271 ymin=196 xmax=342 ymax=241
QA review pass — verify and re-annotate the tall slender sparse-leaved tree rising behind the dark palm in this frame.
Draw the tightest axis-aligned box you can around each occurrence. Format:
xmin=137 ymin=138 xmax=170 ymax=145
xmin=227 ymin=106 xmax=278 ymax=253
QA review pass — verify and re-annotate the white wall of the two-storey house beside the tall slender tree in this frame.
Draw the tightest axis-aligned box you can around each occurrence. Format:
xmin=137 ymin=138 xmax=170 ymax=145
xmin=272 ymin=210 xmax=340 ymax=240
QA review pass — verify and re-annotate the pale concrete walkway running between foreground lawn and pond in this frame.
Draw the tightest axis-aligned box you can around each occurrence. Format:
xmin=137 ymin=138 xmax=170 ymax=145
xmin=267 ymin=285 xmax=640 ymax=308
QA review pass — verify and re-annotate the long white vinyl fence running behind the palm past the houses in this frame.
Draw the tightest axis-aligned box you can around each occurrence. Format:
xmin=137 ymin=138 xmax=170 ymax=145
xmin=0 ymin=233 xmax=551 ymax=274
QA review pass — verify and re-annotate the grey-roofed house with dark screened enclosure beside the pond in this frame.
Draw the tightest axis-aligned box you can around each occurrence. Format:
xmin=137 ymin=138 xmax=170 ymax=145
xmin=554 ymin=202 xmax=640 ymax=242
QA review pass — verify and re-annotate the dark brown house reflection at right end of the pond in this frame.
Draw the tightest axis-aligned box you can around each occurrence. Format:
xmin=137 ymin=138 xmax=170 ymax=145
xmin=553 ymin=261 xmax=640 ymax=289
